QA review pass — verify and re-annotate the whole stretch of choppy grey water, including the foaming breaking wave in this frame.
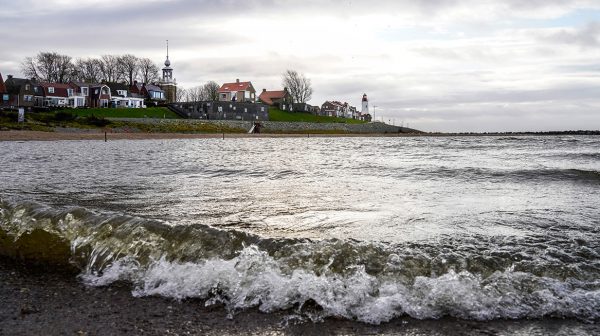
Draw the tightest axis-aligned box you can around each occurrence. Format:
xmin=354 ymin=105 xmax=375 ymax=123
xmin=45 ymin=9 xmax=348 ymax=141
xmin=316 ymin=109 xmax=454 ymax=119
xmin=0 ymin=136 xmax=600 ymax=324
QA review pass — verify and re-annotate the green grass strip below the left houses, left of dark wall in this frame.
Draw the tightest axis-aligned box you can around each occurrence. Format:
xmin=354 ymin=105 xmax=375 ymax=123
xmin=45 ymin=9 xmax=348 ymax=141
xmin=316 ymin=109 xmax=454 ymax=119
xmin=64 ymin=107 xmax=180 ymax=119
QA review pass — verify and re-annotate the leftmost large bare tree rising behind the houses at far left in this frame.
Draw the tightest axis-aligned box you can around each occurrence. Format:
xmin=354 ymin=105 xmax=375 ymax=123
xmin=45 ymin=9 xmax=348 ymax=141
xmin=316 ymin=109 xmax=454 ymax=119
xmin=21 ymin=52 xmax=73 ymax=83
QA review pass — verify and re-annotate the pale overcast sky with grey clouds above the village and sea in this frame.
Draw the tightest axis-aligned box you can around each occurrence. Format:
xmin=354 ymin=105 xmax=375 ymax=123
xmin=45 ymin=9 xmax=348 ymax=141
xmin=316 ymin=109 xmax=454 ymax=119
xmin=0 ymin=0 xmax=600 ymax=132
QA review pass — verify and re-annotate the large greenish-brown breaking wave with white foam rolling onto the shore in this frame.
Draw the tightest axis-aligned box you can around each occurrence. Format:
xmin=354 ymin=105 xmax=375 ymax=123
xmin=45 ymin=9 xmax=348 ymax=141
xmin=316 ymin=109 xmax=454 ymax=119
xmin=0 ymin=201 xmax=600 ymax=324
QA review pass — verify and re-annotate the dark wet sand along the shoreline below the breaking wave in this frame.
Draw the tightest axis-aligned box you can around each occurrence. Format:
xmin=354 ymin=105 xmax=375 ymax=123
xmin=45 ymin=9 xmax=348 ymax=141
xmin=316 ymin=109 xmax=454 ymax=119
xmin=0 ymin=257 xmax=600 ymax=336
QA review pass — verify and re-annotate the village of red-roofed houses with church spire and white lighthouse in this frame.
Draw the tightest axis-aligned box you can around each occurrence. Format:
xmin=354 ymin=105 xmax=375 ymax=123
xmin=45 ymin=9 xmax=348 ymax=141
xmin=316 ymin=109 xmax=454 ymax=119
xmin=0 ymin=47 xmax=372 ymax=122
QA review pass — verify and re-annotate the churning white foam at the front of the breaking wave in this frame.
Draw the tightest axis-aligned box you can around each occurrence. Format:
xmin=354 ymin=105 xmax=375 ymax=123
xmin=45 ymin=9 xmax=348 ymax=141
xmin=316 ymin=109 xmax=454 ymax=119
xmin=83 ymin=246 xmax=600 ymax=324
